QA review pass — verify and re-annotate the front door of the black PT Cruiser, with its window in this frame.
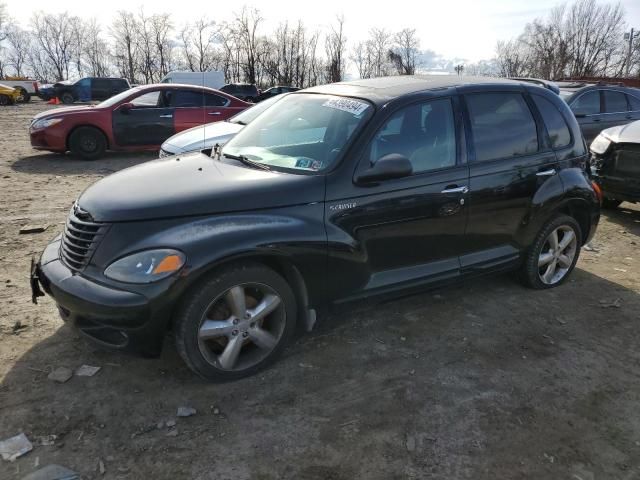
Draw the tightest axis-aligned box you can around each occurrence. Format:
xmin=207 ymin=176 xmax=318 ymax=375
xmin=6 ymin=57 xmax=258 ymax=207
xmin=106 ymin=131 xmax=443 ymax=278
xmin=325 ymin=98 xmax=468 ymax=300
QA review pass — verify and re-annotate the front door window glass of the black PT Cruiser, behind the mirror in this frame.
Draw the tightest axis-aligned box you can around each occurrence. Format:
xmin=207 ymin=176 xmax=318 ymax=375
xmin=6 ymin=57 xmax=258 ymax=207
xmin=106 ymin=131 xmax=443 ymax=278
xmin=369 ymin=99 xmax=456 ymax=174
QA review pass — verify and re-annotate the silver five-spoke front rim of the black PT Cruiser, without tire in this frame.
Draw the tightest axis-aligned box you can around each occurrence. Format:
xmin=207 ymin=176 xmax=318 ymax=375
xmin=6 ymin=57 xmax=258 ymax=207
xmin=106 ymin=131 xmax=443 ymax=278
xmin=198 ymin=283 xmax=286 ymax=371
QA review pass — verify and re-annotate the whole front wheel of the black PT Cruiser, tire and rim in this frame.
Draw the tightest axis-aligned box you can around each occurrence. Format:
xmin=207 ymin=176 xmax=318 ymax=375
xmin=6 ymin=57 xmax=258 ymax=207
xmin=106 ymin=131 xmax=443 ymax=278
xmin=174 ymin=263 xmax=296 ymax=382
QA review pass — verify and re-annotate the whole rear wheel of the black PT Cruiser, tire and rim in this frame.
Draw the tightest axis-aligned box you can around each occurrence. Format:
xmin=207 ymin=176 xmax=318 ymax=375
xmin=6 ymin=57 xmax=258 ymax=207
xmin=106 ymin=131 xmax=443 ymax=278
xmin=521 ymin=215 xmax=582 ymax=290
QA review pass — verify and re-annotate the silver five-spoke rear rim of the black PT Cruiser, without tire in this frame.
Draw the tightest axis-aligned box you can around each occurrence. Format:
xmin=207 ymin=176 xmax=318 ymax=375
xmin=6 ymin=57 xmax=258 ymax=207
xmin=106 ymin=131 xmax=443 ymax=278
xmin=538 ymin=225 xmax=578 ymax=285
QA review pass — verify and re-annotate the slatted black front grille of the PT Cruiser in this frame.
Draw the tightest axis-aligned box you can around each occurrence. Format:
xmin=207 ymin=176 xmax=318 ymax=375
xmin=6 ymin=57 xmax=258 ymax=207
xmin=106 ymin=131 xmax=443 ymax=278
xmin=60 ymin=207 xmax=109 ymax=272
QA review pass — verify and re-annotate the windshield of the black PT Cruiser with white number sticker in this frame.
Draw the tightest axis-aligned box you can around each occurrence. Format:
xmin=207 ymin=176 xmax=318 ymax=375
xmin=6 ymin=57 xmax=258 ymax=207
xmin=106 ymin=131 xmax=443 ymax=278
xmin=223 ymin=93 xmax=373 ymax=172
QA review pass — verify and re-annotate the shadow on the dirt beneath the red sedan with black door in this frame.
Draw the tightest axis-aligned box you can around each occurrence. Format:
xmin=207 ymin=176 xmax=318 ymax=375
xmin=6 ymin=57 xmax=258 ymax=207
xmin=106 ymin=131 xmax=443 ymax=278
xmin=11 ymin=152 xmax=158 ymax=175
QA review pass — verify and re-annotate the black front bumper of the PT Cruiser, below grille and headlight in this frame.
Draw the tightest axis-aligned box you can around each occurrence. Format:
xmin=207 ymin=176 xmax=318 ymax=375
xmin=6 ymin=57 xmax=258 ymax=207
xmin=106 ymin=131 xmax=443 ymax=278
xmin=31 ymin=239 xmax=171 ymax=356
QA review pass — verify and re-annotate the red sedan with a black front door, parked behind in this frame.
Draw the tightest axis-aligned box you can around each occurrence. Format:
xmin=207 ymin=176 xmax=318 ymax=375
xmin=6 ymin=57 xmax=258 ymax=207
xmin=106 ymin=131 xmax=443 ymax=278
xmin=29 ymin=84 xmax=251 ymax=160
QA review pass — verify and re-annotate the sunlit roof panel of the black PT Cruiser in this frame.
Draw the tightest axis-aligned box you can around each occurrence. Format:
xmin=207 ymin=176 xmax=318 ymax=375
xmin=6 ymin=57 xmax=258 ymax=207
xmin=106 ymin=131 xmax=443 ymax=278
xmin=304 ymin=75 xmax=524 ymax=103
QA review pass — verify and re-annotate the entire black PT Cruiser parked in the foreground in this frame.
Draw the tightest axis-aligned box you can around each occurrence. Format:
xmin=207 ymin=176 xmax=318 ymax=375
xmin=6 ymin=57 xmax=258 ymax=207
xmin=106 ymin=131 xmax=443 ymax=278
xmin=32 ymin=76 xmax=600 ymax=380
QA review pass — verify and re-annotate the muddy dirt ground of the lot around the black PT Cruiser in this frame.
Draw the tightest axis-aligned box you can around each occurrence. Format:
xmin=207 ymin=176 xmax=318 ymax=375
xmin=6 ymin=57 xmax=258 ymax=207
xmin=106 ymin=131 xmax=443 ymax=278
xmin=0 ymin=101 xmax=640 ymax=480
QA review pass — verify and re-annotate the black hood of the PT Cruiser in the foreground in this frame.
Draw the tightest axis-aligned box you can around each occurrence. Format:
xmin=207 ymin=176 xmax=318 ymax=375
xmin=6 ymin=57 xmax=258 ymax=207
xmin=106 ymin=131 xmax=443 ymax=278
xmin=78 ymin=153 xmax=324 ymax=222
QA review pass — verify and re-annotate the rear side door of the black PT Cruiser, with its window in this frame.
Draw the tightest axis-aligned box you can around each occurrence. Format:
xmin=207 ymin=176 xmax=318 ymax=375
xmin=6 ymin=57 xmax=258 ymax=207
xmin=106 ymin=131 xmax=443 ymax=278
xmin=460 ymin=90 xmax=558 ymax=272
